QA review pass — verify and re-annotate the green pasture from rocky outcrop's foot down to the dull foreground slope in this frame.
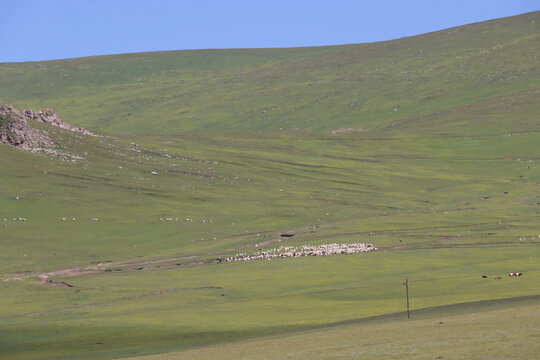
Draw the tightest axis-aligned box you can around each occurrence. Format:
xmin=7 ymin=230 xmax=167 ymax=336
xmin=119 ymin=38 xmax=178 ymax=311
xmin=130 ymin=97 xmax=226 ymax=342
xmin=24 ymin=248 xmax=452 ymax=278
xmin=0 ymin=124 xmax=540 ymax=359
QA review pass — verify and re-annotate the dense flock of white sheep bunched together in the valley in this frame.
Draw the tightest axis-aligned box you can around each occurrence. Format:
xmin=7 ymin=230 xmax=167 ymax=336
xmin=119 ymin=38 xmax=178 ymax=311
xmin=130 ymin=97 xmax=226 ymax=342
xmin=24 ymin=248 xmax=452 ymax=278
xmin=218 ymin=243 xmax=377 ymax=262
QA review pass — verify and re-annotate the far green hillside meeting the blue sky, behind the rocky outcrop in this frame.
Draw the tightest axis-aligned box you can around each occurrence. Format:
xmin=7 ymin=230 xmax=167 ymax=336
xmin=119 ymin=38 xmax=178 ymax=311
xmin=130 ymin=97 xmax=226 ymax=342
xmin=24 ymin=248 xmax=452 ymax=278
xmin=0 ymin=12 xmax=540 ymax=134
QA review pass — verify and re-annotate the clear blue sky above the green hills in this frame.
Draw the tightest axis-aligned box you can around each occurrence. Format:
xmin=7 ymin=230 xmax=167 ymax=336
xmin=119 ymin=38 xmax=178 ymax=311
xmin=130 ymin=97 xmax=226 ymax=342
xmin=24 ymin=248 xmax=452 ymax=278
xmin=0 ymin=0 xmax=540 ymax=62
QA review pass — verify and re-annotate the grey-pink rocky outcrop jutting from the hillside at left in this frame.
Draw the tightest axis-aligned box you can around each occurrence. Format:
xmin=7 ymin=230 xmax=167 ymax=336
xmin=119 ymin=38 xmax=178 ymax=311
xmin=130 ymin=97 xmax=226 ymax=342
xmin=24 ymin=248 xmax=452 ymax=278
xmin=0 ymin=105 xmax=96 ymax=155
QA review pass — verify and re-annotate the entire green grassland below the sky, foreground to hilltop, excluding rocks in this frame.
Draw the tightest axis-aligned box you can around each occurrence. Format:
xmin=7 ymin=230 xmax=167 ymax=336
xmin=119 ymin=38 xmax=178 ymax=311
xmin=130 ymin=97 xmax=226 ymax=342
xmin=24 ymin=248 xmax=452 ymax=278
xmin=0 ymin=12 xmax=540 ymax=359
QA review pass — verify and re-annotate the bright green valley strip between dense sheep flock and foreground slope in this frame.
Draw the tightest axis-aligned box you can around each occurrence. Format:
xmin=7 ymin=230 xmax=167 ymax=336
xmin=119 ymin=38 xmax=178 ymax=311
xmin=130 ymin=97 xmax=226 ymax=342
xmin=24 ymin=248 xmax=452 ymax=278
xmin=1 ymin=245 xmax=540 ymax=359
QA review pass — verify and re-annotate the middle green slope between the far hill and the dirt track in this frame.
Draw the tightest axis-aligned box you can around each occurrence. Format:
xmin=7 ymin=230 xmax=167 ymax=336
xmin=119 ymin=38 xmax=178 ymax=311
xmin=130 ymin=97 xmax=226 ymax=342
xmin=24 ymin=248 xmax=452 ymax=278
xmin=0 ymin=128 xmax=539 ymax=277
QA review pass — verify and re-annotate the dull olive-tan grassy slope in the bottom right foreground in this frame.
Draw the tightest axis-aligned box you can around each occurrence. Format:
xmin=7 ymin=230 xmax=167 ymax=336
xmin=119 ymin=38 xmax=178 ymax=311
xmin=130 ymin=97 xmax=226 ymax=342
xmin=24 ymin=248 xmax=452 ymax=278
xmin=122 ymin=299 xmax=540 ymax=360
